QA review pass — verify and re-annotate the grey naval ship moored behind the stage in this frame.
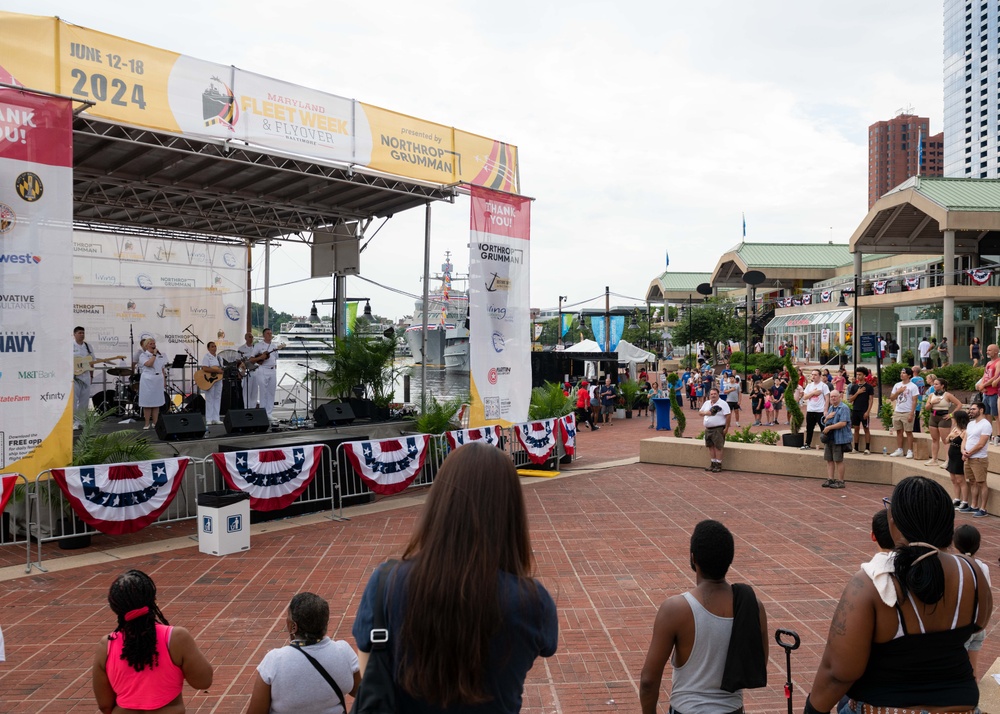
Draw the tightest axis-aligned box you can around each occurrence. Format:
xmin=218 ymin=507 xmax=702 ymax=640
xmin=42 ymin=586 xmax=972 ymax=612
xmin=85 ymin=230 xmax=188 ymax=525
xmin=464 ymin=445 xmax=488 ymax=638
xmin=406 ymin=252 xmax=469 ymax=372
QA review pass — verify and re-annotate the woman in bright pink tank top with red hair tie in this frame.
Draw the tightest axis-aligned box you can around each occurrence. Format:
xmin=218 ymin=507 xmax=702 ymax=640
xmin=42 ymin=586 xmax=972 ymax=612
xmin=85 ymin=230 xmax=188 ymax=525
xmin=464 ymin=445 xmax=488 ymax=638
xmin=93 ymin=570 xmax=212 ymax=714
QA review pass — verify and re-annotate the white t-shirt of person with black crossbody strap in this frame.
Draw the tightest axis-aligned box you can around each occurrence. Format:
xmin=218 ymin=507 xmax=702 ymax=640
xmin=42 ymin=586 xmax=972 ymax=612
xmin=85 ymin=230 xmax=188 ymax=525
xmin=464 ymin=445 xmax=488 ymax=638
xmin=257 ymin=637 xmax=358 ymax=714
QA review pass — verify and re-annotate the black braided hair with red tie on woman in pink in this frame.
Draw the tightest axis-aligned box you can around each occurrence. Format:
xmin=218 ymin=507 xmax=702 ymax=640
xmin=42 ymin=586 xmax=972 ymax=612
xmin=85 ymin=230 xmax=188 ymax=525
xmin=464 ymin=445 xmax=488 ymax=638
xmin=108 ymin=570 xmax=170 ymax=672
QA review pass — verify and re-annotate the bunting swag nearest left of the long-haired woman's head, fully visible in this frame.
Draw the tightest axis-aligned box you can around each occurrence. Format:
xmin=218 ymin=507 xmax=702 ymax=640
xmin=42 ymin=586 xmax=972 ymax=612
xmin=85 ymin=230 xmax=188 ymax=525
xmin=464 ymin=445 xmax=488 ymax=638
xmin=344 ymin=434 xmax=430 ymax=496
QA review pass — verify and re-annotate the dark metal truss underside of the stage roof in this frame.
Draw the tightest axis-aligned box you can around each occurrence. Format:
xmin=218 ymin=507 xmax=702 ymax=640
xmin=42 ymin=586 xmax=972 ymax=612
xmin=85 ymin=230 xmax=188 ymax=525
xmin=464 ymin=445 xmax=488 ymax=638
xmin=73 ymin=115 xmax=458 ymax=242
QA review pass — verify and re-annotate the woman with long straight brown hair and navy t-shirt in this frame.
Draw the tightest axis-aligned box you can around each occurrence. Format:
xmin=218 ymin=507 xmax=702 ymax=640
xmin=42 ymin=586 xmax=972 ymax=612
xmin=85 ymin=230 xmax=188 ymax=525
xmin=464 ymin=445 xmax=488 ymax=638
xmin=354 ymin=442 xmax=558 ymax=713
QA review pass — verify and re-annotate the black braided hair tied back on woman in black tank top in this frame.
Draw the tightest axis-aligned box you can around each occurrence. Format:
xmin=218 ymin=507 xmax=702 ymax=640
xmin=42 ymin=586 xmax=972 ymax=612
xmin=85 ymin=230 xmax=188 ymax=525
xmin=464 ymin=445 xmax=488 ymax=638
xmin=892 ymin=476 xmax=955 ymax=605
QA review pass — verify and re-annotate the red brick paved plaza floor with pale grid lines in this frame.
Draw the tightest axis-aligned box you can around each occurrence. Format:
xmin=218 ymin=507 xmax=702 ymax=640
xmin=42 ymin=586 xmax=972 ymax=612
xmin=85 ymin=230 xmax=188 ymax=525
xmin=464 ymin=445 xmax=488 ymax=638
xmin=0 ymin=419 xmax=1000 ymax=714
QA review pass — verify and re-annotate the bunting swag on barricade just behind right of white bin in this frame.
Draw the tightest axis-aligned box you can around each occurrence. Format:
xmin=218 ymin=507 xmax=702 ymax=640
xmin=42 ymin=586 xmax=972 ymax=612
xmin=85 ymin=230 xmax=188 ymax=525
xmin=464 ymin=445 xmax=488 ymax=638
xmin=212 ymin=444 xmax=323 ymax=511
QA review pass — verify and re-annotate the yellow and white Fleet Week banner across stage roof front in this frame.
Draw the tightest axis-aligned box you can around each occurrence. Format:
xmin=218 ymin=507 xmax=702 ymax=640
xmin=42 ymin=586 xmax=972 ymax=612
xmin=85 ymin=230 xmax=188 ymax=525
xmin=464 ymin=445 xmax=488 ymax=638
xmin=0 ymin=12 xmax=519 ymax=193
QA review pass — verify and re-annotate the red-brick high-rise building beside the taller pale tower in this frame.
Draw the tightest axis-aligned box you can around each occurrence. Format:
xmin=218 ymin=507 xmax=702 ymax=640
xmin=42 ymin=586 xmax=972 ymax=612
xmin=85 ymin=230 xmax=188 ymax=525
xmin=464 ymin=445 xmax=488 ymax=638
xmin=868 ymin=113 xmax=940 ymax=209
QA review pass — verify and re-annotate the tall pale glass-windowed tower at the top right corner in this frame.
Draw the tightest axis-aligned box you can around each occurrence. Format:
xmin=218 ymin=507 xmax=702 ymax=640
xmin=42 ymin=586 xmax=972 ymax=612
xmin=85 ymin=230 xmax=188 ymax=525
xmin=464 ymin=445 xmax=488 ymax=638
xmin=944 ymin=0 xmax=1000 ymax=179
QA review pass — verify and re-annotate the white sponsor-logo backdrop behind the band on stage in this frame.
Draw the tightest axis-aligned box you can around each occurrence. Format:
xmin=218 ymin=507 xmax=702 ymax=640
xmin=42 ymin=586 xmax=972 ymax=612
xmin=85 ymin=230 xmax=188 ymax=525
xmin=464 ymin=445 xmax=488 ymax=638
xmin=73 ymin=231 xmax=246 ymax=392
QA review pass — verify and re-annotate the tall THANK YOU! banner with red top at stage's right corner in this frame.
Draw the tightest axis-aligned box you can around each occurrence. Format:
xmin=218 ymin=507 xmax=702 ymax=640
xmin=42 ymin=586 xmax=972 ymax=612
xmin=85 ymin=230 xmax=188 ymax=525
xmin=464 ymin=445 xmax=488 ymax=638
xmin=469 ymin=187 xmax=531 ymax=426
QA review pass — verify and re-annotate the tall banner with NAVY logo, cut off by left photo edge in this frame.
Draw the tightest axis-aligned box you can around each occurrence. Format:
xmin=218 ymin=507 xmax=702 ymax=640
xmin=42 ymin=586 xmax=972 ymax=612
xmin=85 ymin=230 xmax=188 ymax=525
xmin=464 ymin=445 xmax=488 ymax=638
xmin=0 ymin=90 xmax=73 ymax=479
